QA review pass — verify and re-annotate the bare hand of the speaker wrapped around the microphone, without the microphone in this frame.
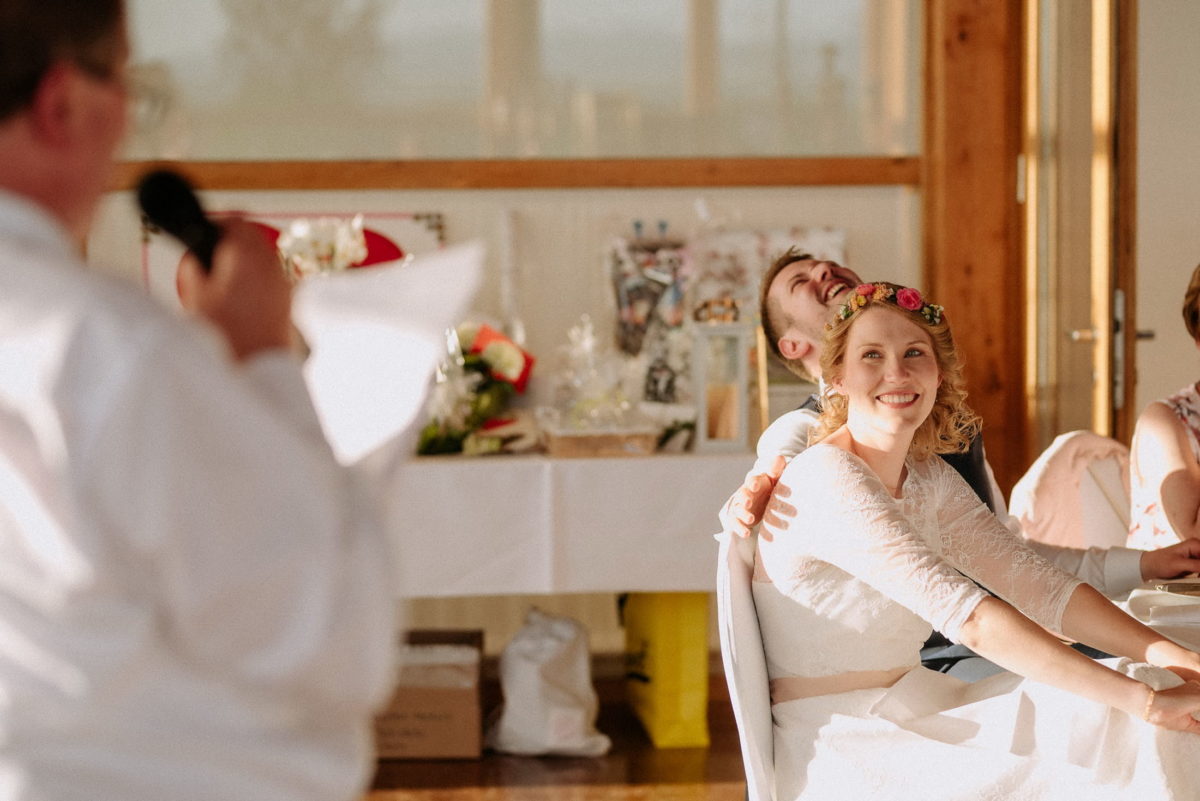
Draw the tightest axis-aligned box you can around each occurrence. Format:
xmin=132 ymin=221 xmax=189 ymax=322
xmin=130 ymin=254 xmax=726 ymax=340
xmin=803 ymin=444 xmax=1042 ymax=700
xmin=175 ymin=219 xmax=293 ymax=361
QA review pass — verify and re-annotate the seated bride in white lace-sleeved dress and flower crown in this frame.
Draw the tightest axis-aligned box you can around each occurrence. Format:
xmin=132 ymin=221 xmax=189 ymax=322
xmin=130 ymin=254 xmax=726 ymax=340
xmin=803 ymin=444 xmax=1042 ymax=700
xmin=754 ymin=283 xmax=1200 ymax=801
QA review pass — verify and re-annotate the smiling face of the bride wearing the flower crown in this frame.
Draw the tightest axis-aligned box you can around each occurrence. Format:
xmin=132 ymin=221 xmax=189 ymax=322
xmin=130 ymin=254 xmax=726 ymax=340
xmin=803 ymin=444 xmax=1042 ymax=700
xmin=832 ymin=306 xmax=942 ymax=434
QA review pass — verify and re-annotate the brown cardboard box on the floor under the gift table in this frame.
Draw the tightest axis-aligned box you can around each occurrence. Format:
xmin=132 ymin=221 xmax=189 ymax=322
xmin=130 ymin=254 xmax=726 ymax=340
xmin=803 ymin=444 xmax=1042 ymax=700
xmin=374 ymin=630 xmax=484 ymax=759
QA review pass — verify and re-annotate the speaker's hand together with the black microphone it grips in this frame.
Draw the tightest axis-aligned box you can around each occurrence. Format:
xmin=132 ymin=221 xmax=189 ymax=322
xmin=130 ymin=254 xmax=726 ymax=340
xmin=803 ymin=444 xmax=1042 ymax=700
xmin=138 ymin=170 xmax=294 ymax=360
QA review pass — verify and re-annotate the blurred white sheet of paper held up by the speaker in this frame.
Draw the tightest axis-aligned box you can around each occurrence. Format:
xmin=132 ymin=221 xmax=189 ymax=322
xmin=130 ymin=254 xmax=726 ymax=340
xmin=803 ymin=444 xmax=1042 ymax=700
xmin=293 ymin=242 xmax=484 ymax=464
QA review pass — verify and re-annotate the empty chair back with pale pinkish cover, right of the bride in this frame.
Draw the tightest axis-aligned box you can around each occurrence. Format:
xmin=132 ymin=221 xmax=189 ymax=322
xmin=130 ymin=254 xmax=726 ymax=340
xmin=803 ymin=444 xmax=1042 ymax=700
xmin=1009 ymin=430 xmax=1129 ymax=548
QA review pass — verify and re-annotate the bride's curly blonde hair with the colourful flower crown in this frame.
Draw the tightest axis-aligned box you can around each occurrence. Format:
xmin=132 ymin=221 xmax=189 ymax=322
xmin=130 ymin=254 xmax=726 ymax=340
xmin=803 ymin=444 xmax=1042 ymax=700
xmin=810 ymin=282 xmax=980 ymax=459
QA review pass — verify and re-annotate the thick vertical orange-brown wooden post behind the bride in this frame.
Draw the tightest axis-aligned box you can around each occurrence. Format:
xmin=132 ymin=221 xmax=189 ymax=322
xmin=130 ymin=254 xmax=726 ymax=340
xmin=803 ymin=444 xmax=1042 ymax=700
xmin=924 ymin=0 xmax=1031 ymax=493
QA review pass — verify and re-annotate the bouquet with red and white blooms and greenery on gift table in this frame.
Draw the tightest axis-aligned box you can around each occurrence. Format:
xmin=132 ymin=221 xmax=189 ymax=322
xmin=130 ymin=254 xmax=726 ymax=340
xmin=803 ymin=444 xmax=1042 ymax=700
xmin=416 ymin=323 xmax=534 ymax=454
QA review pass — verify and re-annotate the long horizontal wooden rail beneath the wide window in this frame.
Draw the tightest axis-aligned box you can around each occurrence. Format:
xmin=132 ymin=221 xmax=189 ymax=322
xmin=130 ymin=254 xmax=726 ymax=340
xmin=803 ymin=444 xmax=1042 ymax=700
xmin=113 ymin=156 xmax=922 ymax=189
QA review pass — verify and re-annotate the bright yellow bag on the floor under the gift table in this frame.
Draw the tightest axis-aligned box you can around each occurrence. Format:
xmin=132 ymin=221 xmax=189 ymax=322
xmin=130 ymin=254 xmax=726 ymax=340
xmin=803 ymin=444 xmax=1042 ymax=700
xmin=623 ymin=592 xmax=709 ymax=748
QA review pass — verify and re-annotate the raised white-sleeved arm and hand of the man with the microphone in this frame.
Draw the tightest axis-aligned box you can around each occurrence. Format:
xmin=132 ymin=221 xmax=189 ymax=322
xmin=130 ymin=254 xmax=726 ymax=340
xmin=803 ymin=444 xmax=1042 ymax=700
xmin=84 ymin=221 xmax=397 ymax=715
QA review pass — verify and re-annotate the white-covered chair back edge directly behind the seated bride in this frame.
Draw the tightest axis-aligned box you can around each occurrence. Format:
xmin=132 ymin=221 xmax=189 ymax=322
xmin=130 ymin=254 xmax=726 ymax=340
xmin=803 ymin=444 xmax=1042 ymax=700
xmin=716 ymin=534 xmax=775 ymax=801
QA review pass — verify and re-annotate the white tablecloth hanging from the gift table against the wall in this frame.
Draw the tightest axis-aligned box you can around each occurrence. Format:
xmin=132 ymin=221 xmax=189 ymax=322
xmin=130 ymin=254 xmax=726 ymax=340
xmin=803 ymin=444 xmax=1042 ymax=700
xmin=389 ymin=452 xmax=754 ymax=597
